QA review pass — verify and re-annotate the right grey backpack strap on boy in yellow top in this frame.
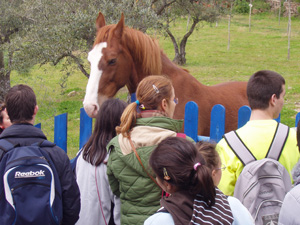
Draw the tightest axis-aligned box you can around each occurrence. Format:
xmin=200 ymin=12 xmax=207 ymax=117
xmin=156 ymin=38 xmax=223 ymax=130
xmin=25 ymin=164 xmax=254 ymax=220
xmin=266 ymin=123 xmax=290 ymax=161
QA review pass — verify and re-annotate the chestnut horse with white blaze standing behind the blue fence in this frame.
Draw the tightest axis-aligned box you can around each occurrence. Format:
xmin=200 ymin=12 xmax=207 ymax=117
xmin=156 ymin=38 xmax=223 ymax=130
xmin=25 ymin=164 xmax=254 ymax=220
xmin=83 ymin=12 xmax=249 ymax=136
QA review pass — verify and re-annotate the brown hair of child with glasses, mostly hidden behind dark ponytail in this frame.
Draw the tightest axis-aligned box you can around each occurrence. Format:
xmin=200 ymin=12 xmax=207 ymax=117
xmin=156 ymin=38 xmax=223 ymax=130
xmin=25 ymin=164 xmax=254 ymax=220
xmin=196 ymin=141 xmax=221 ymax=170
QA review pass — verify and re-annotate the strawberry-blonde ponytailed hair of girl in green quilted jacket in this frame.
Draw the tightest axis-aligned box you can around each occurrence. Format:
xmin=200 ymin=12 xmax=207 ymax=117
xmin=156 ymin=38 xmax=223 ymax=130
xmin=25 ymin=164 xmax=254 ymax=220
xmin=116 ymin=75 xmax=173 ymax=137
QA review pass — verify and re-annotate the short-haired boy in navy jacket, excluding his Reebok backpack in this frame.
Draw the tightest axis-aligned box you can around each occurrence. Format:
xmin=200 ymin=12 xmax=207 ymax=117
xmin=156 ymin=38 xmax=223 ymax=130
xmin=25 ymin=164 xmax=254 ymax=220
xmin=0 ymin=84 xmax=80 ymax=225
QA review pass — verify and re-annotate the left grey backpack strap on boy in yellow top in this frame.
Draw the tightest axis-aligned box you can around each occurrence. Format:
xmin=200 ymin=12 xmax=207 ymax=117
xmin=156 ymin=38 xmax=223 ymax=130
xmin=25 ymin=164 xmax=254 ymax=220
xmin=224 ymin=130 xmax=256 ymax=166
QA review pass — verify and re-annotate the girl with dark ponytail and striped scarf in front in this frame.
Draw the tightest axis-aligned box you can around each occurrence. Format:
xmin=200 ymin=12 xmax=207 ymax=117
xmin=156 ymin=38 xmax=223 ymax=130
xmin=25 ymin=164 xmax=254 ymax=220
xmin=144 ymin=137 xmax=254 ymax=225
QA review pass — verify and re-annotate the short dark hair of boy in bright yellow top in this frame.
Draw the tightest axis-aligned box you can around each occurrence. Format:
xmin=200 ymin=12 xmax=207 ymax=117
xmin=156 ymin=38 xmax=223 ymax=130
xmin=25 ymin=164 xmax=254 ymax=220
xmin=247 ymin=70 xmax=285 ymax=109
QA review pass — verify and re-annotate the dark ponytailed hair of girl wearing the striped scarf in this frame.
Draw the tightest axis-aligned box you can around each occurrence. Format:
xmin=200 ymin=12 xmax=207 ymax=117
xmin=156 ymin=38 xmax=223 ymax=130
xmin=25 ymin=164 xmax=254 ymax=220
xmin=149 ymin=137 xmax=216 ymax=206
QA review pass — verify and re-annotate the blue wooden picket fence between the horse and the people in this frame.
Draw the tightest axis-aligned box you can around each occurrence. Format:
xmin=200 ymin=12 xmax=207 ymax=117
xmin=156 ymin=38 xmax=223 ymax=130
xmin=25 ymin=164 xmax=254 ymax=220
xmin=42 ymin=101 xmax=300 ymax=152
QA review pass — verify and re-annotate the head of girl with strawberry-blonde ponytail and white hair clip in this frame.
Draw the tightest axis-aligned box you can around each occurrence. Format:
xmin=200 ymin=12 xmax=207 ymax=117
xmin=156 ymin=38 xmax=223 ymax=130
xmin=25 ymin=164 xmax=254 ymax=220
xmin=117 ymin=75 xmax=178 ymax=136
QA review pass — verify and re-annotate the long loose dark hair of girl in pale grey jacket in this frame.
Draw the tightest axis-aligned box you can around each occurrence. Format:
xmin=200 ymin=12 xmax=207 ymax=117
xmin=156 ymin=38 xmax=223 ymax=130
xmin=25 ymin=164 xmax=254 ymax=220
xmin=83 ymin=99 xmax=127 ymax=166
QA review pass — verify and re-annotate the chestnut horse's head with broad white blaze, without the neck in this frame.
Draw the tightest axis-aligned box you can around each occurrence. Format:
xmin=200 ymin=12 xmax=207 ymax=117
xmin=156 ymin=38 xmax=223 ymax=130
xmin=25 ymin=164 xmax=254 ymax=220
xmin=83 ymin=13 xmax=134 ymax=117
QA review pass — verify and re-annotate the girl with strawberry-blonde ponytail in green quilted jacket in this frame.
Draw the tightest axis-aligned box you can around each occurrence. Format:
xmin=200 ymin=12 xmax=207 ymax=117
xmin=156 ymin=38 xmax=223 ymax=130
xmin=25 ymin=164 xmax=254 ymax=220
xmin=107 ymin=75 xmax=190 ymax=225
